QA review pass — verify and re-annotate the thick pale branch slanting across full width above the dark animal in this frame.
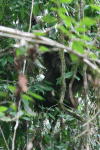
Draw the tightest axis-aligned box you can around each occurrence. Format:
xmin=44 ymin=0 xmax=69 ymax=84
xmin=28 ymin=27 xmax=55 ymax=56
xmin=0 ymin=26 xmax=100 ymax=73
